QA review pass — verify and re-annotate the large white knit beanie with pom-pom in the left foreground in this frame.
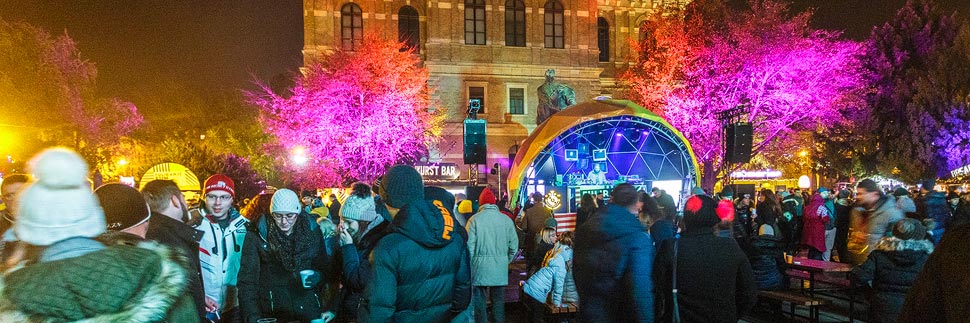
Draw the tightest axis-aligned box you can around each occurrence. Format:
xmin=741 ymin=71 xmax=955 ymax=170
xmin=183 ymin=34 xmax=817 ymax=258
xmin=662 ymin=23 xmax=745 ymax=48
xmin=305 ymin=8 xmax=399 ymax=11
xmin=13 ymin=148 xmax=105 ymax=246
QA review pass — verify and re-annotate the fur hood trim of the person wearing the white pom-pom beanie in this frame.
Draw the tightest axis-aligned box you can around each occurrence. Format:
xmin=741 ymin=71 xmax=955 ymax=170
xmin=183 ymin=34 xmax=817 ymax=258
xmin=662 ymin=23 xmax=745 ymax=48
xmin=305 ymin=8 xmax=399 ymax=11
xmin=0 ymin=241 xmax=189 ymax=323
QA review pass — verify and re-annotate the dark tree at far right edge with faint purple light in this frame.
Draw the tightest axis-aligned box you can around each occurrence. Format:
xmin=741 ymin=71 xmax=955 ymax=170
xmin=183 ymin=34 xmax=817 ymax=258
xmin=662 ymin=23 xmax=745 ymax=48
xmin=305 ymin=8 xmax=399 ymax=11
xmin=856 ymin=0 xmax=970 ymax=182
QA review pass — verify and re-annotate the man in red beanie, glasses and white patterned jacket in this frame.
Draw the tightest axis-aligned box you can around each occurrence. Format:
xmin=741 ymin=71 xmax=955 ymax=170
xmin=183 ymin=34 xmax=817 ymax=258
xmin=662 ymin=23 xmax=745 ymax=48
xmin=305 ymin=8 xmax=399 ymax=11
xmin=196 ymin=174 xmax=248 ymax=323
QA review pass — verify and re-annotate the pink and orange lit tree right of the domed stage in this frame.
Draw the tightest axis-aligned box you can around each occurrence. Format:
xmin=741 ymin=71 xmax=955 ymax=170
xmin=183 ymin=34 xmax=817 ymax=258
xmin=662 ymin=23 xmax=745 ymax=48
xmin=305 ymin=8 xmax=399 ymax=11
xmin=623 ymin=0 xmax=864 ymax=187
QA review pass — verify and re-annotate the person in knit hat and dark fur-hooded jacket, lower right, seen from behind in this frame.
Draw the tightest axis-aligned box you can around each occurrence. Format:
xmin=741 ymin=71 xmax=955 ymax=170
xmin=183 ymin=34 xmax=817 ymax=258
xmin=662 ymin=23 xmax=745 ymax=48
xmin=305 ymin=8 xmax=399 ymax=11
xmin=852 ymin=218 xmax=933 ymax=323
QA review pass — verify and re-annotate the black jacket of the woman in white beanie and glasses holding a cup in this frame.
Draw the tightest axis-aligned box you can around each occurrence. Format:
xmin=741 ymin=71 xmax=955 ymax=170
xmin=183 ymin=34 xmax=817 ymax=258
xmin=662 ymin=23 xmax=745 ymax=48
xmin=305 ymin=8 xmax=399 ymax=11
xmin=237 ymin=214 xmax=330 ymax=323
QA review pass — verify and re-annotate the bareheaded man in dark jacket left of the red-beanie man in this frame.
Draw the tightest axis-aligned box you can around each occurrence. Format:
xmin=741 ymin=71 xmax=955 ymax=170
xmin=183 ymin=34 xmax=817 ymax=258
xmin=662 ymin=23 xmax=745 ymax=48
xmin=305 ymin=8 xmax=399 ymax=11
xmin=141 ymin=179 xmax=206 ymax=322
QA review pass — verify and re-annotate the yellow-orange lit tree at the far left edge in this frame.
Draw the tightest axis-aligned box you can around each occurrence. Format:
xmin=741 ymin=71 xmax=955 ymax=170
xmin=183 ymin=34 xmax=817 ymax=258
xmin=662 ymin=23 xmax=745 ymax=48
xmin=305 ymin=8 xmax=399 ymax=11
xmin=0 ymin=20 xmax=143 ymax=165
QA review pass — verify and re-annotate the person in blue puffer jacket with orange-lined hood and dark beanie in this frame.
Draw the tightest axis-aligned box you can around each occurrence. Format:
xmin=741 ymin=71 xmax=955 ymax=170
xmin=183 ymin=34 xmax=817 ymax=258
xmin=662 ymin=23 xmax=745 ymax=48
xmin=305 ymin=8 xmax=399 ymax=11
xmin=364 ymin=165 xmax=471 ymax=322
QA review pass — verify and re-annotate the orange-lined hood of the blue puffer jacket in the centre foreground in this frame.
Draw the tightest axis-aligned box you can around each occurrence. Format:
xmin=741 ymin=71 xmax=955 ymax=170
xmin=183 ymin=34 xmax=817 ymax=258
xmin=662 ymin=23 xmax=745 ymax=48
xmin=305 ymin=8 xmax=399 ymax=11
xmin=393 ymin=200 xmax=459 ymax=248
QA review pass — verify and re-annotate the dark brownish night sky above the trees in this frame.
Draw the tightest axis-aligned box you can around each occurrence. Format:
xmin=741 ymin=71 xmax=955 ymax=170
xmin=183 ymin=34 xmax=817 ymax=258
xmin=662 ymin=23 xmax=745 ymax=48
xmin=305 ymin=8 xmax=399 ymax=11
xmin=0 ymin=0 xmax=970 ymax=100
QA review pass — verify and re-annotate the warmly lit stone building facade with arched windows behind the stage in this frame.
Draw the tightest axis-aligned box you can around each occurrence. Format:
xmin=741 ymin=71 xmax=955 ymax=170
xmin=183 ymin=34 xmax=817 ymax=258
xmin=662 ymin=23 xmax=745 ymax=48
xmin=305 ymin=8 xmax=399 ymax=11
xmin=303 ymin=0 xmax=685 ymax=190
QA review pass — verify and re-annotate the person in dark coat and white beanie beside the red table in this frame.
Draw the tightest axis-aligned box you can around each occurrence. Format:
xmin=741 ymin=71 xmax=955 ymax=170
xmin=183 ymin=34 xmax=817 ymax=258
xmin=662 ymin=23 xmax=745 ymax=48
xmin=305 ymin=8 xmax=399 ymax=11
xmin=747 ymin=224 xmax=786 ymax=290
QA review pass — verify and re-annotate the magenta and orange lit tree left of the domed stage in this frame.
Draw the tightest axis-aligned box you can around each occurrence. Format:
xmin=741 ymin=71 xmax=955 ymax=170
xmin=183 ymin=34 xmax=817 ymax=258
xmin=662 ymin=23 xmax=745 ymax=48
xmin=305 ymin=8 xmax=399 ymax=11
xmin=250 ymin=35 xmax=444 ymax=187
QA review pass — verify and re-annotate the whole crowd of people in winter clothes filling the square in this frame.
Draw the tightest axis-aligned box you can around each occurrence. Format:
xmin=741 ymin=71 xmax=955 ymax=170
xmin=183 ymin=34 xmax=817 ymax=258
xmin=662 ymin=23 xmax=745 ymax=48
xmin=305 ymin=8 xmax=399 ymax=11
xmin=0 ymin=148 xmax=970 ymax=323
